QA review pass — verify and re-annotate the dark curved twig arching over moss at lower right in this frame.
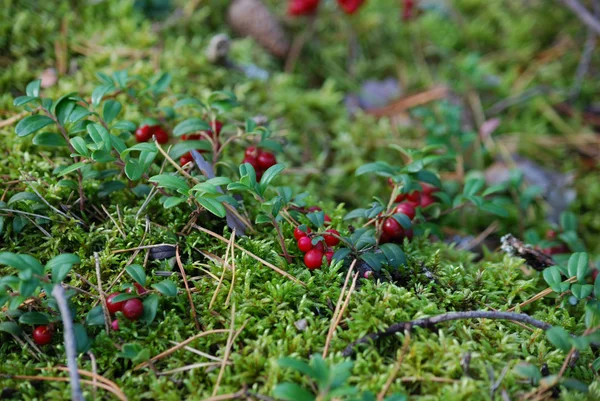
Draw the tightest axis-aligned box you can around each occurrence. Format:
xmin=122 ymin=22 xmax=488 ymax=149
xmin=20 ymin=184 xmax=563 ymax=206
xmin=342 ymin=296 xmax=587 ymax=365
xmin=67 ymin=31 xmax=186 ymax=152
xmin=343 ymin=311 xmax=552 ymax=356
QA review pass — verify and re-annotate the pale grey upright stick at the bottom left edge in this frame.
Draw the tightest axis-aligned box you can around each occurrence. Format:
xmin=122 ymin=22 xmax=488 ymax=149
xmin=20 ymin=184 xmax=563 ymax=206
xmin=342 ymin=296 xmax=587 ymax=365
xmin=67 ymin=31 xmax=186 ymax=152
xmin=52 ymin=283 xmax=85 ymax=401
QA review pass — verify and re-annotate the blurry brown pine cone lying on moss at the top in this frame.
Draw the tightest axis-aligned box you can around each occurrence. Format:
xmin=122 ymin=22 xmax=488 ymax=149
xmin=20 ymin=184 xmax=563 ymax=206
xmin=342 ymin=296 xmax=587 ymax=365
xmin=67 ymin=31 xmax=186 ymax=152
xmin=227 ymin=0 xmax=290 ymax=58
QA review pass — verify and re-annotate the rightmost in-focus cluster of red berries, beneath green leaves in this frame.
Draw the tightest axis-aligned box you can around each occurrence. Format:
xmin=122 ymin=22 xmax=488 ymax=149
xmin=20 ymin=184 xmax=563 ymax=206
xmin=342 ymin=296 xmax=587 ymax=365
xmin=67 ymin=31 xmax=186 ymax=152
xmin=379 ymin=179 xmax=438 ymax=244
